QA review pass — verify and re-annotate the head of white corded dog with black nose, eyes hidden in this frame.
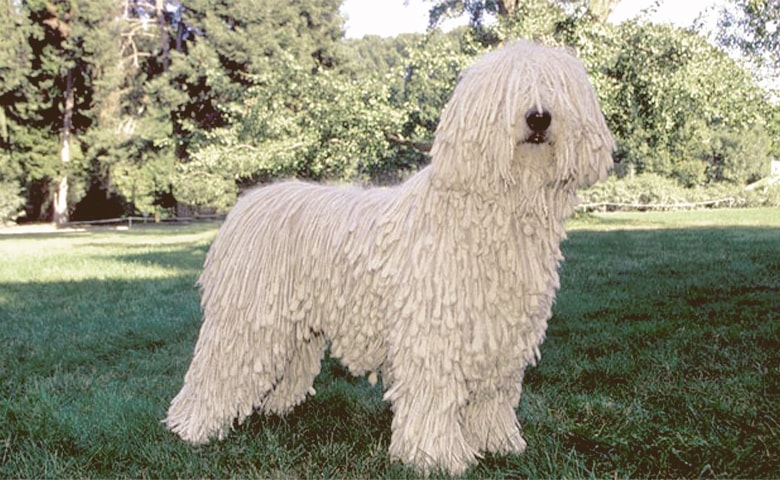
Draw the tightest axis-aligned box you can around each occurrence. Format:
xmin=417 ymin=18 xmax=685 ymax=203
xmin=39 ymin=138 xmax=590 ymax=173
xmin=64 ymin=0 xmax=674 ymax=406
xmin=431 ymin=42 xmax=614 ymax=199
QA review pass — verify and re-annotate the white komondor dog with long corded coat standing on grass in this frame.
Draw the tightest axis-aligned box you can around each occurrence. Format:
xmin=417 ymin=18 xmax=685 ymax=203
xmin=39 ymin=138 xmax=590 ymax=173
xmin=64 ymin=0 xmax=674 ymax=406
xmin=165 ymin=42 xmax=613 ymax=474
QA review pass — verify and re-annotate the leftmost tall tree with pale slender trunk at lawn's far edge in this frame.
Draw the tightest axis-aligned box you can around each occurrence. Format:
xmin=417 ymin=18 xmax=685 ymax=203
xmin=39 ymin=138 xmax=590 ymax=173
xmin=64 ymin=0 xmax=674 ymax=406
xmin=4 ymin=0 xmax=125 ymax=223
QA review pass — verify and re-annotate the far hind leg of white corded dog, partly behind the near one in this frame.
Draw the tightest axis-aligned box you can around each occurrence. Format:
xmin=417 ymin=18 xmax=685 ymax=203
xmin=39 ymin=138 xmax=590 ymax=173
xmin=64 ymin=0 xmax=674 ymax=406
xmin=262 ymin=334 xmax=327 ymax=415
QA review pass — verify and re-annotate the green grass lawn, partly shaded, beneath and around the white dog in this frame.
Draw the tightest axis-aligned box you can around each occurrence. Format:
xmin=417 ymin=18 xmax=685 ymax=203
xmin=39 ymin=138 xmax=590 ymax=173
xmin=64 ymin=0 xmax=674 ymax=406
xmin=0 ymin=209 xmax=780 ymax=478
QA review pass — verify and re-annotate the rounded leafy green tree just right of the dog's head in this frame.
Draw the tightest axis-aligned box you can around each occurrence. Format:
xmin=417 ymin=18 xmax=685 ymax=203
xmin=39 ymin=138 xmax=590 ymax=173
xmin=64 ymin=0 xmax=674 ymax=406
xmin=605 ymin=22 xmax=772 ymax=186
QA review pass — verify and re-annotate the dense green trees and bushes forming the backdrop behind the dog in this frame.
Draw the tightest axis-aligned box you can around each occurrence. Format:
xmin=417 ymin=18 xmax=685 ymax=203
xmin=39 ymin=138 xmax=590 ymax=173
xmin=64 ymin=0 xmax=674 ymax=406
xmin=0 ymin=0 xmax=780 ymax=221
